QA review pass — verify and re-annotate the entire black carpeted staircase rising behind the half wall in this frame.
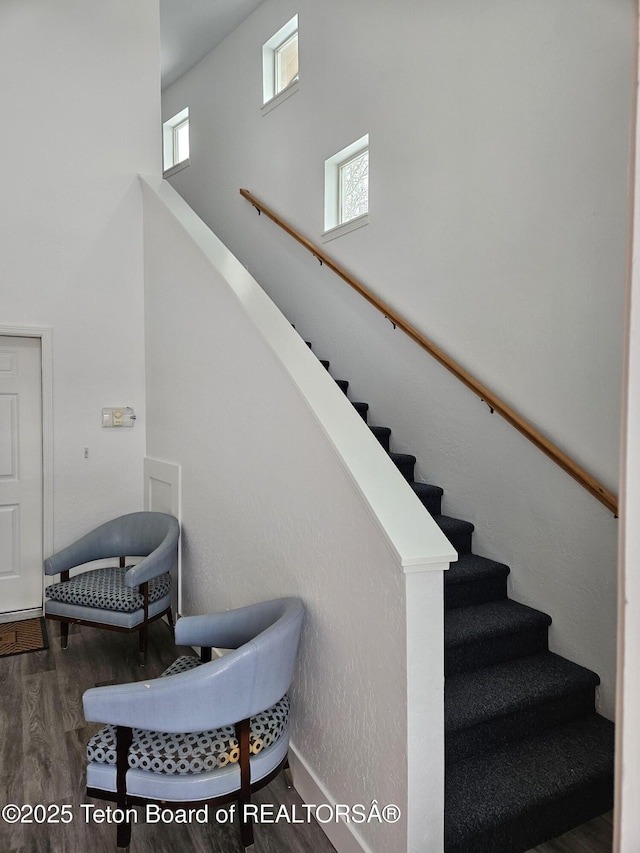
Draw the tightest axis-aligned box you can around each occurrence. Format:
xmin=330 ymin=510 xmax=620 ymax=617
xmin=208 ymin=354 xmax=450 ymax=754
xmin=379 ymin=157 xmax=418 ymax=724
xmin=322 ymin=346 xmax=614 ymax=853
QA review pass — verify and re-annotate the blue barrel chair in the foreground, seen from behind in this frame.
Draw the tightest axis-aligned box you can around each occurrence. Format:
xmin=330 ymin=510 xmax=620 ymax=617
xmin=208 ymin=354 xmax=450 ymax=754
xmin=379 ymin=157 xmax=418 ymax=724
xmin=83 ymin=598 xmax=304 ymax=849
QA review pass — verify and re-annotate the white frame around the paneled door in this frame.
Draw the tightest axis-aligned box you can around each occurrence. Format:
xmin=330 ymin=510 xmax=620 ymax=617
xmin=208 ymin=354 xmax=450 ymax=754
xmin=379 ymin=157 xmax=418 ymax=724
xmin=0 ymin=325 xmax=53 ymax=623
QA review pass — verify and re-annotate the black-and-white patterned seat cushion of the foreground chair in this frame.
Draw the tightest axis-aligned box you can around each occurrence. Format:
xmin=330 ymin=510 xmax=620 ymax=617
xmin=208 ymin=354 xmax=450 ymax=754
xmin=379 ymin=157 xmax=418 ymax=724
xmin=87 ymin=656 xmax=289 ymax=775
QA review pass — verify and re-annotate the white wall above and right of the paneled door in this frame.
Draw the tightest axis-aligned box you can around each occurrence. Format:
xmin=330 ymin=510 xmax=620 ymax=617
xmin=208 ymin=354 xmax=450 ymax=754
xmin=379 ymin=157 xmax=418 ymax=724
xmin=0 ymin=0 xmax=160 ymax=547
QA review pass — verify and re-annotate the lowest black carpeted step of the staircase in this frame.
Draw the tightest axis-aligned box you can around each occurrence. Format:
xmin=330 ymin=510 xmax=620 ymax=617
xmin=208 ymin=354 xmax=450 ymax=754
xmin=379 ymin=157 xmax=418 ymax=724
xmin=445 ymin=714 xmax=614 ymax=853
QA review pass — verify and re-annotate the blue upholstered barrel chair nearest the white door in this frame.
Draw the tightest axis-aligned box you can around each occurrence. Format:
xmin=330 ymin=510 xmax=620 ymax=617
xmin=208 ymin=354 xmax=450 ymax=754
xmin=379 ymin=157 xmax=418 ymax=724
xmin=44 ymin=512 xmax=180 ymax=666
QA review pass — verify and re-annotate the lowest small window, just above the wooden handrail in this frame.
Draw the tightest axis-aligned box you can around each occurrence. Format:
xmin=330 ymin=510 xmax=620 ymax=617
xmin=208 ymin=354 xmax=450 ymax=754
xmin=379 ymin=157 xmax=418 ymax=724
xmin=324 ymin=134 xmax=369 ymax=239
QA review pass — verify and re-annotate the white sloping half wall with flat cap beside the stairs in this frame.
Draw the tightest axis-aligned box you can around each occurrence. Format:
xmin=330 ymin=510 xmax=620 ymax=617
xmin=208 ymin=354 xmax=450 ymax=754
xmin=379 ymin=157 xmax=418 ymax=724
xmin=143 ymin=176 xmax=455 ymax=853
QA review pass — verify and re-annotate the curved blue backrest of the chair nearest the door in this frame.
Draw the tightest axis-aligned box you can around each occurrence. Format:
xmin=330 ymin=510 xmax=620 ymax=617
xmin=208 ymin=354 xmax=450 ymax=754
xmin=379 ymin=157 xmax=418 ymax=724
xmin=44 ymin=512 xmax=180 ymax=575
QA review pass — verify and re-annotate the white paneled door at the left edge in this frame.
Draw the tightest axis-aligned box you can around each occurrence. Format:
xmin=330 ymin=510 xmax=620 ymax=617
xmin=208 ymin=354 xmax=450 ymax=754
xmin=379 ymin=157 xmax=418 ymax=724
xmin=0 ymin=336 xmax=42 ymax=613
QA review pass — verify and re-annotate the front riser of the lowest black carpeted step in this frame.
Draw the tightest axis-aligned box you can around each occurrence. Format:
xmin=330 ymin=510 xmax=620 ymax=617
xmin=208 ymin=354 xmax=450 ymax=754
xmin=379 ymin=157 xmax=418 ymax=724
xmin=444 ymin=776 xmax=613 ymax=853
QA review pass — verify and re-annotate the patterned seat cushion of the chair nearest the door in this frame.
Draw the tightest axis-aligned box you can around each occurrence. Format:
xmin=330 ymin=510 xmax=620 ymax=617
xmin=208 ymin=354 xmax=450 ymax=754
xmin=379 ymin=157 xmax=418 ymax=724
xmin=46 ymin=566 xmax=171 ymax=613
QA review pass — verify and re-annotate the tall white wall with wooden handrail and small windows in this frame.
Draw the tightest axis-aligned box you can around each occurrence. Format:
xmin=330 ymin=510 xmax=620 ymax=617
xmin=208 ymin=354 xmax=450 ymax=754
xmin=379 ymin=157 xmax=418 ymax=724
xmin=163 ymin=0 xmax=633 ymax=716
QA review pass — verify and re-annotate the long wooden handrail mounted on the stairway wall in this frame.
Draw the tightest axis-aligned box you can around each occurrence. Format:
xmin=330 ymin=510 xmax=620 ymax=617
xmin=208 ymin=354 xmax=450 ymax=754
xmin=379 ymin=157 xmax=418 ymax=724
xmin=240 ymin=189 xmax=618 ymax=516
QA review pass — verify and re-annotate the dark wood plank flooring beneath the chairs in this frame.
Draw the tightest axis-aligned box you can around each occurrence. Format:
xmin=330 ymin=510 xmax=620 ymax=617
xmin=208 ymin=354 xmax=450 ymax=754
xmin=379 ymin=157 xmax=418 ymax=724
xmin=0 ymin=622 xmax=612 ymax=853
